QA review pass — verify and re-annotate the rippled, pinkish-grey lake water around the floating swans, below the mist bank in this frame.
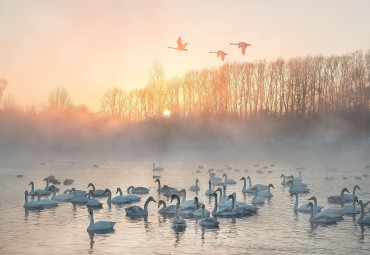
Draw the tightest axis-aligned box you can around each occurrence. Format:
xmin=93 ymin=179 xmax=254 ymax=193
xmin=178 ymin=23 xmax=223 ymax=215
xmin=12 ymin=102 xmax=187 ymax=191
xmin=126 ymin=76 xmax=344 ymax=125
xmin=0 ymin=154 xmax=370 ymax=254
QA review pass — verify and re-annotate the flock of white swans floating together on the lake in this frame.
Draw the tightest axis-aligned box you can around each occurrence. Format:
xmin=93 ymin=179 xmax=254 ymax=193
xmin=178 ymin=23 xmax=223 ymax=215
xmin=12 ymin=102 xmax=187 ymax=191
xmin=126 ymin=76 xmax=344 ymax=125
xmin=23 ymin=163 xmax=370 ymax=231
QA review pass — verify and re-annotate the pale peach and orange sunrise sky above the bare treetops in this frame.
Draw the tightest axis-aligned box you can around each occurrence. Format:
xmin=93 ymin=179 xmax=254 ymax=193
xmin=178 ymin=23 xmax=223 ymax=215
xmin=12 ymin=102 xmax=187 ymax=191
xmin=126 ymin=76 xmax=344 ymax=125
xmin=0 ymin=0 xmax=370 ymax=111
